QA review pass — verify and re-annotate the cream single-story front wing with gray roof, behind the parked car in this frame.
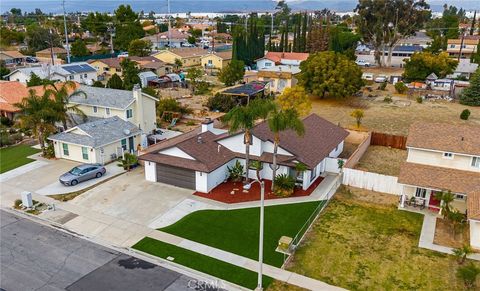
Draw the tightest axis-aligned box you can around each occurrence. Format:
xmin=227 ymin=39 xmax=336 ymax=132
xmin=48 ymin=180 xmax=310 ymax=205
xmin=48 ymin=116 xmax=142 ymax=164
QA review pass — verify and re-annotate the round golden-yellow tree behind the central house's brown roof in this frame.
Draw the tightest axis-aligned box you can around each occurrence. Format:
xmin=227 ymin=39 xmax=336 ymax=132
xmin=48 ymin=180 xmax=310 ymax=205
xmin=275 ymin=86 xmax=312 ymax=116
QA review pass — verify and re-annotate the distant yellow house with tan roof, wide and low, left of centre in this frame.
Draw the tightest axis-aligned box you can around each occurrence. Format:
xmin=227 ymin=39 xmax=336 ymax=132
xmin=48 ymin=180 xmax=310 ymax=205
xmin=153 ymin=47 xmax=208 ymax=67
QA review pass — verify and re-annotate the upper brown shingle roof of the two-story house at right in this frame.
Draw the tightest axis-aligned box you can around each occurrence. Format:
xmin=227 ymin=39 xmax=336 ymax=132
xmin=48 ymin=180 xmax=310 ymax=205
xmin=407 ymin=122 xmax=480 ymax=155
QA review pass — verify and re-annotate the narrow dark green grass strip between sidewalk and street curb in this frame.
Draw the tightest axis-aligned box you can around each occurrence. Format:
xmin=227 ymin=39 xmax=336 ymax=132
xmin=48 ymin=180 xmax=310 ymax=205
xmin=132 ymin=237 xmax=273 ymax=290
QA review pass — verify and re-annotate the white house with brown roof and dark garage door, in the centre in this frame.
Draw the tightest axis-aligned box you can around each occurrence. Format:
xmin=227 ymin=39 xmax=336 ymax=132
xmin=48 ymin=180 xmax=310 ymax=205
xmin=139 ymin=114 xmax=348 ymax=193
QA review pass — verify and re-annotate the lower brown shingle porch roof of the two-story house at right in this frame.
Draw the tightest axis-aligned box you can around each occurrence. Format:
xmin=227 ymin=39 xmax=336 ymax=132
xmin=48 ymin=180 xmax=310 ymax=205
xmin=398 ymin=162 xmax=480 ymax=195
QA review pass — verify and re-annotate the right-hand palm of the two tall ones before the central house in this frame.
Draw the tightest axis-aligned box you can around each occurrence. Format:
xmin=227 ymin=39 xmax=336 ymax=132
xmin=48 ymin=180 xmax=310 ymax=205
xmin=267 ymin=107 xmax=305 ymax=191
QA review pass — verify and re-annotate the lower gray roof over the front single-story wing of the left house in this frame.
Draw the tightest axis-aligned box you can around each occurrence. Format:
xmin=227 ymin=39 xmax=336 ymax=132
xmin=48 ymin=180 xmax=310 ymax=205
xmin=48 ymin=116 xmax=141 ymax=148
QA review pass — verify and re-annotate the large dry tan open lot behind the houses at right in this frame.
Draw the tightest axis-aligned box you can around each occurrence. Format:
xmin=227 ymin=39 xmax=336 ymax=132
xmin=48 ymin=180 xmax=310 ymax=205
xmin=312 ymin=89 xmax=480 ymax=135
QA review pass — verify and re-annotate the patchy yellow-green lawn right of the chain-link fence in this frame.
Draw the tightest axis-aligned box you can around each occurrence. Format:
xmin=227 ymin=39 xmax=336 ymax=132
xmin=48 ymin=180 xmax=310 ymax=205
xmin=287 ymin=188 xmax=480 ymax=290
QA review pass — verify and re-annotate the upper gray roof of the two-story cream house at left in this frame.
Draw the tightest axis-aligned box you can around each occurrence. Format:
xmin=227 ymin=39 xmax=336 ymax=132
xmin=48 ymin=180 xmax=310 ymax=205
xmin=69 ymin=85 xmax=135 ymax=109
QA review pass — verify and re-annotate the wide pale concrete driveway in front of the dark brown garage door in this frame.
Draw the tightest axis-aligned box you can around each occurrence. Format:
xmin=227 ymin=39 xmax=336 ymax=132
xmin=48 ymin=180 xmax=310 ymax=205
xmin=67 ymin=167 xmax=193 ymax=226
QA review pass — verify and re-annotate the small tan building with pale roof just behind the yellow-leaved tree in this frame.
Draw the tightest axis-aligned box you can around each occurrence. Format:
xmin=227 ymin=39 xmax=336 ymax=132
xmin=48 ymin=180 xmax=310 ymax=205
xmin=257 ymin=65 xmax=300 ymax=93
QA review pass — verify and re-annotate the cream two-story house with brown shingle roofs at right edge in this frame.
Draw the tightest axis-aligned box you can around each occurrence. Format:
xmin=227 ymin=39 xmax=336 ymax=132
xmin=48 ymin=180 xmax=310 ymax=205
xmin=398 ymin=123 xmax=480 ymax=249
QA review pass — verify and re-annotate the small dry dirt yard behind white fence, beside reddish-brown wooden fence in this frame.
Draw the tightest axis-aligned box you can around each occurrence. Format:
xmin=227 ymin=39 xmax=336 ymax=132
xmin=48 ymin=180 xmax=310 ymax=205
xmin=355 ymin=146 xmax=407 ymax=176
